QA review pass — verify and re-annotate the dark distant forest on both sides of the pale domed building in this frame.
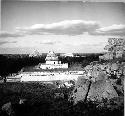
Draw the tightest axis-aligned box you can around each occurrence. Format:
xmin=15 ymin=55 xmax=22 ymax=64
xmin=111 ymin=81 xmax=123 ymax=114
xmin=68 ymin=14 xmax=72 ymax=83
xmin=0 ymin=54 xmax=100 ymax=76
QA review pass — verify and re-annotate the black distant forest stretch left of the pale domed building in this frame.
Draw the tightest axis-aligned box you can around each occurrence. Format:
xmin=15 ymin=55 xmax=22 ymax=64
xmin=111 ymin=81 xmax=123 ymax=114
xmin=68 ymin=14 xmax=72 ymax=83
xmin=0 ymin=55 xmax=45 ymax=76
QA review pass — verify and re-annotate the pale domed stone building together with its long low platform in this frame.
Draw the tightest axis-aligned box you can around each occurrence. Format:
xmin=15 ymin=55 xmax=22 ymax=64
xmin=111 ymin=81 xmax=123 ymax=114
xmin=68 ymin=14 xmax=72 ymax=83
xmin=7 ymin=52 xmax=86 ymax=82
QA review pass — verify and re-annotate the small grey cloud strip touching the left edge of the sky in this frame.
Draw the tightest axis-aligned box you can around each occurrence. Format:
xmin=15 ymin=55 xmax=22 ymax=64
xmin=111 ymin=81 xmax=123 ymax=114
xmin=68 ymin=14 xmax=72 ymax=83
xmin=0 ymin=31 xmax=24 ymax=38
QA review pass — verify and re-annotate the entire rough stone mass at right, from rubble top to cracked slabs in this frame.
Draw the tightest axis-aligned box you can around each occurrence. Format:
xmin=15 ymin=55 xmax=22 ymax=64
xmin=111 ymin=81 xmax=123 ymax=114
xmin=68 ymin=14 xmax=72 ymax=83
xmin=71 ymin=62 xmax=125 ymax=104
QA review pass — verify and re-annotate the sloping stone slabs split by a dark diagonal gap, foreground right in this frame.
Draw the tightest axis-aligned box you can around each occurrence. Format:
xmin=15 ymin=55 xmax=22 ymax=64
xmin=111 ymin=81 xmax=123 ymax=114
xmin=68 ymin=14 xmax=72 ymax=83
xmin=70 ymin=78 xmax=118 ymax=104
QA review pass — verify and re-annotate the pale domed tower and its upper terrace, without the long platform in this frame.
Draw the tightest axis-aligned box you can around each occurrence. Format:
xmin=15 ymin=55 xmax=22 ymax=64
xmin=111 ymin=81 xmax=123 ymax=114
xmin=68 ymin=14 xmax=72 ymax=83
xmin=39 ymin=51 xmax=68 ymax=69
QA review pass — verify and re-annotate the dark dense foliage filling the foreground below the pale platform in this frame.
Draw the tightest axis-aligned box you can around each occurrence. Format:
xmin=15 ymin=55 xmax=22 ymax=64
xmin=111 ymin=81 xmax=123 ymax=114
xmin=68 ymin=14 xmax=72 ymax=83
xmin=0 ymin=83 xmax=123 ymax=116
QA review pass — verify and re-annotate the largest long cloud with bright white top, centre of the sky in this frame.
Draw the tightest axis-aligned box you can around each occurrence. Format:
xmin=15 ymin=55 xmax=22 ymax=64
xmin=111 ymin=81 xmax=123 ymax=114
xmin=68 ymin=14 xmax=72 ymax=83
xmin=17 ymin=20 xmax=99 ymax=35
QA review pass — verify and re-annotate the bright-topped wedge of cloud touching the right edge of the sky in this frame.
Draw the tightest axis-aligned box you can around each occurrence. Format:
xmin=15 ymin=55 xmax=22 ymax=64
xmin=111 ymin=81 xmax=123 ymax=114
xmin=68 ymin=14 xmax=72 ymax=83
xmin=90 ymin=24 xmax=125 ymax=36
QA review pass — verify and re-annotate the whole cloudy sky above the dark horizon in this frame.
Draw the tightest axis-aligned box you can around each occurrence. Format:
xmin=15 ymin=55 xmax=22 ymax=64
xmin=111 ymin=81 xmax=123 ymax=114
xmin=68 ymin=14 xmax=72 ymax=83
xmin=0 ymin=0 xmax=125 ymax=54
